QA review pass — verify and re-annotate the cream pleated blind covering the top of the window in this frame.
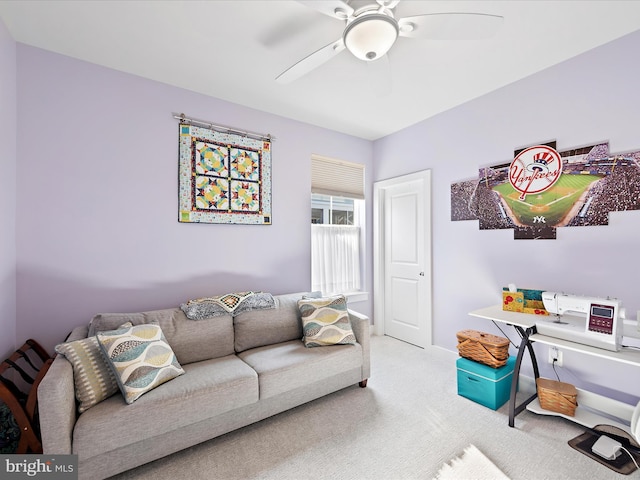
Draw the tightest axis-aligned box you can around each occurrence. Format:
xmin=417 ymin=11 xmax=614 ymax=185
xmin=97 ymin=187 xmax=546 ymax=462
xmin=311 ymin=155 xmax=364 ymax=200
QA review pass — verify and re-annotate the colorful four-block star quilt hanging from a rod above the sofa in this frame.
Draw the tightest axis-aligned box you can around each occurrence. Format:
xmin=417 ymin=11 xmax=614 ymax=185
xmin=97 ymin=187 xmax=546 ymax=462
xmin=176 ymin=115 xmax=272 ymax=225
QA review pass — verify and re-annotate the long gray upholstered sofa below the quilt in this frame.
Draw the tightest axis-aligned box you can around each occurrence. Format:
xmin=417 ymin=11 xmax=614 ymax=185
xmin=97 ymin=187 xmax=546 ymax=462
xmin=38 ymin=293 xmax=370 ymax=479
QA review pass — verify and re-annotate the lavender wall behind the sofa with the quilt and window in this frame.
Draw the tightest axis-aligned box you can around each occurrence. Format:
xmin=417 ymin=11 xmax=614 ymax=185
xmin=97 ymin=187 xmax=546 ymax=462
xmin=17 ymin=44 xmax=373 ymax=347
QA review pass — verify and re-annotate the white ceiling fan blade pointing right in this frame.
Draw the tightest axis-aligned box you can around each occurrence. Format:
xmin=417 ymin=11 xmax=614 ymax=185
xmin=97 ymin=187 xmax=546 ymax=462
xmin=398 ymin=13 xmax=504 ymax=40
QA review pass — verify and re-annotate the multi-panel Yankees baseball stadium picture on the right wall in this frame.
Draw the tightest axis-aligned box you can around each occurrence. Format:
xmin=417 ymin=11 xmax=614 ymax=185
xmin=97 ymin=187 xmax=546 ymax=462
xmin=451 ymin=142 xmax=640 ymax=239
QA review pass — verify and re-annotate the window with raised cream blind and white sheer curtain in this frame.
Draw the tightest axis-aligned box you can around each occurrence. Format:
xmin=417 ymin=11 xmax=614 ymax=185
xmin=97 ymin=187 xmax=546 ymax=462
xmin=311 ymin=155 xmax=364 ymax=294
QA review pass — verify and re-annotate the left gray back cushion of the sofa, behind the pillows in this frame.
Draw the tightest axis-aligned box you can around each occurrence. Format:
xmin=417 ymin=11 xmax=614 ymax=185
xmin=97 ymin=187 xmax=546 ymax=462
xmin=89 ymin=308 xmax=234 ymax=366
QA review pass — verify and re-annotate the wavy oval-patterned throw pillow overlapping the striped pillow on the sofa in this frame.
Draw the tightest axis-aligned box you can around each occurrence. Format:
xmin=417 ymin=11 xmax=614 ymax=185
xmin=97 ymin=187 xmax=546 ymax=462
xmin=96 ymin=324 xmax=184 ymax=404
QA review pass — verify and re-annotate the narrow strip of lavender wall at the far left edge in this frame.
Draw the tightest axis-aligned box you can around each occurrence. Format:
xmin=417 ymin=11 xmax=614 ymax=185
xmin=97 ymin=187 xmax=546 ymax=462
xmin=0 ymin=20 xmax=16 ymax=360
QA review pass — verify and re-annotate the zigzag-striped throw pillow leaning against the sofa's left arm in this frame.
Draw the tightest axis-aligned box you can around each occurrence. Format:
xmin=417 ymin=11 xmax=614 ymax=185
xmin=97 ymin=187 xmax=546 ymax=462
xmin=55 ymin=323 xmax=131 ymax=413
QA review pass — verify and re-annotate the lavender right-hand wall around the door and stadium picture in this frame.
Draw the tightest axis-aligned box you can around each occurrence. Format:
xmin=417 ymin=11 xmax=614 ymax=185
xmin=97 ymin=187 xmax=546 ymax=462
xmin=374 ymin=32 xmax=640 ymax=402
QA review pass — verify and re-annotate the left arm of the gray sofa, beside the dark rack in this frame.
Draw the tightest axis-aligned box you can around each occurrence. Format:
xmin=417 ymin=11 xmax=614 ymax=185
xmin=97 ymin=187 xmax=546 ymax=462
xmin=38 ymin=327 xmax=87 ymax=455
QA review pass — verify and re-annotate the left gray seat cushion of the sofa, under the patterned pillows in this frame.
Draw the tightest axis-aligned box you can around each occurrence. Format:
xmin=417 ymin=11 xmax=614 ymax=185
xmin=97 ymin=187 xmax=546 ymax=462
xmin=72 ymin=355 xmax=258 ymax=459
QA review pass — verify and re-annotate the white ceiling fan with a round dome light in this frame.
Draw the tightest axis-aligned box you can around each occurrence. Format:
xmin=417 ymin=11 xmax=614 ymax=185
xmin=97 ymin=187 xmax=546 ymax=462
xmin=276 ymin=0 xmax=503 ymax=83
